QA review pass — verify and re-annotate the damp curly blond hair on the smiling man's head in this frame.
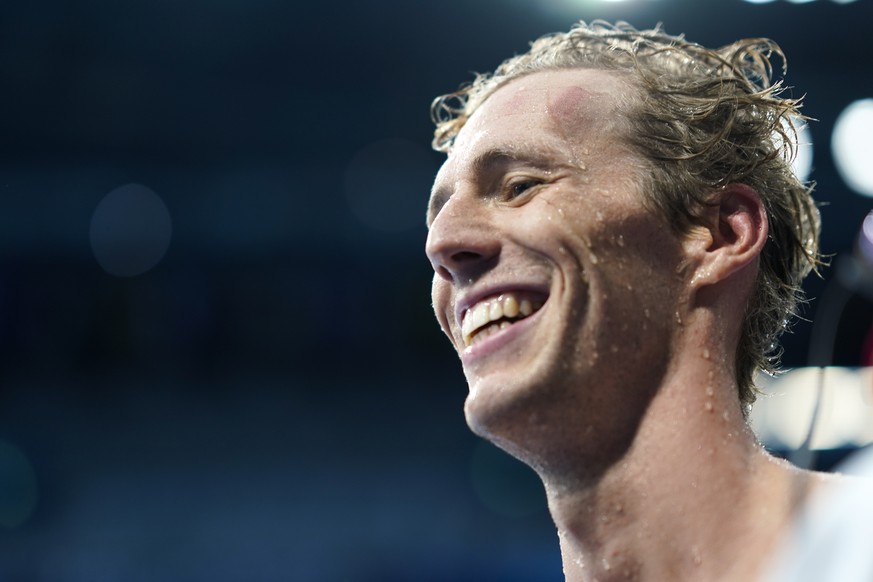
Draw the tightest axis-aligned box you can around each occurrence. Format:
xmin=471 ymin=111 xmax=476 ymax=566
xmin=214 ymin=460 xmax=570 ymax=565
xmin=431 ymin=21 xmax=822 ymax=411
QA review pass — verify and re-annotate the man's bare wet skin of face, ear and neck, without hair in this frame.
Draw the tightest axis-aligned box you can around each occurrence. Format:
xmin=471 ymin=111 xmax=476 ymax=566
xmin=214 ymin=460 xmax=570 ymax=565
xmin=426 ymin=69 xmax=826 ymax=582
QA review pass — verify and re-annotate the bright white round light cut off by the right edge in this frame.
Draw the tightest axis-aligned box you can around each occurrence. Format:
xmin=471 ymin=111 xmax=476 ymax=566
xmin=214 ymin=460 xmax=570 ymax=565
xmin=831 ymin=99 xmax=873 ymax=197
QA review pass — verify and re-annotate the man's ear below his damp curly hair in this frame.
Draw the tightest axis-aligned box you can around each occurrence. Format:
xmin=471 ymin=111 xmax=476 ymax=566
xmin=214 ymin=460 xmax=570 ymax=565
xmin=684 ymin=184 xmax=768 ymax=289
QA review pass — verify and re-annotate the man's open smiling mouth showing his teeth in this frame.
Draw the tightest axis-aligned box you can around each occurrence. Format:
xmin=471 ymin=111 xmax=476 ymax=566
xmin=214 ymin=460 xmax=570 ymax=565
xmin=461 ymin=292 xmax=545 ymax=347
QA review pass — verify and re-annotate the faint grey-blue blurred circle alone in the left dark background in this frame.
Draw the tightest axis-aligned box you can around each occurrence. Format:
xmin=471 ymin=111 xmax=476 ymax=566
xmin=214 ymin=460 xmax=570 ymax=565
xmin=91 ymin=184 xmax=172 ymax=277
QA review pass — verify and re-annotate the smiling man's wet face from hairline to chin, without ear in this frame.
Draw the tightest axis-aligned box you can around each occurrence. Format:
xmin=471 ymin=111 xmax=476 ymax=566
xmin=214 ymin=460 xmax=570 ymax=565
xmin=426 ymin=69 xmax=683 ymax=456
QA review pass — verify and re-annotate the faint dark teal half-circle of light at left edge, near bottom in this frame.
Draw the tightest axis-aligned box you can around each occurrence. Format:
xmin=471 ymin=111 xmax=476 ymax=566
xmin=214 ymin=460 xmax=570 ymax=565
xmin=0 ymin=441 xmax=38 ymax=529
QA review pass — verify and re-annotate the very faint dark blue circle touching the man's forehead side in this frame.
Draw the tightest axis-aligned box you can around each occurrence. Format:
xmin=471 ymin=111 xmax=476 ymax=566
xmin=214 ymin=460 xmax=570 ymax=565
xmin=345 ymin=139 xmax=437 ymax=232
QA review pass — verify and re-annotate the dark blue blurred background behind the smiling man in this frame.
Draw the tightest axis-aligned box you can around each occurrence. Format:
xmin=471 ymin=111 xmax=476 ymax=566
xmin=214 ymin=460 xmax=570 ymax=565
xmin=0 ymin=0 xmax=873 ymax=582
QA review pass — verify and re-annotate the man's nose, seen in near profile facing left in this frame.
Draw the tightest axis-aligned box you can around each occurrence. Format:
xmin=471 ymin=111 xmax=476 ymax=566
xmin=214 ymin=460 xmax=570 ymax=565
xmin=425 ymin=197 xmax=501 ymax=283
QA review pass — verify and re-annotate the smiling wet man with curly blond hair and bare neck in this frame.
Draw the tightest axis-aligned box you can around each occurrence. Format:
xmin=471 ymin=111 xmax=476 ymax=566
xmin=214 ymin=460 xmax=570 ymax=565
xmin=426 ymin=23 xmax=829 ymax=581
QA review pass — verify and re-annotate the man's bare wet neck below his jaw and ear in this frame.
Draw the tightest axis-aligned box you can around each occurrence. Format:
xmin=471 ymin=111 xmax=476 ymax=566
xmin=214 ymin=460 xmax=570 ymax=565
xmin=541 ymin=365 xmax=811 ymax=582
